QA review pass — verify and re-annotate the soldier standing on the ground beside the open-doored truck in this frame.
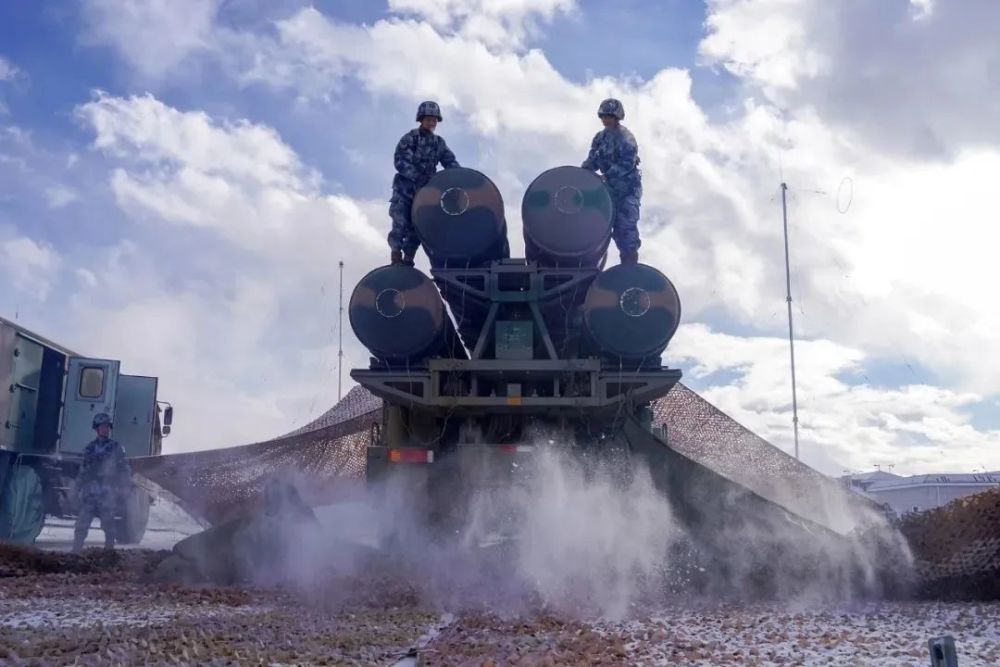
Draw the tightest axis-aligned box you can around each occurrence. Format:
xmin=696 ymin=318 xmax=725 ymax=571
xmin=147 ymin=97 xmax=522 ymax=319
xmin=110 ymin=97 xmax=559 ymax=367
xmin=73 ymin=412 xmax=132 ymax=551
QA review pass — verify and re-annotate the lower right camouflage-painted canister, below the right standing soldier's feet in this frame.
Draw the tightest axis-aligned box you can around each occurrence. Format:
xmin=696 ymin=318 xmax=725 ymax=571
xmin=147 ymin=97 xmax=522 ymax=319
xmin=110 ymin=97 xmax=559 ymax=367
xmin=583 ymin=264 xmax=681 ymax=361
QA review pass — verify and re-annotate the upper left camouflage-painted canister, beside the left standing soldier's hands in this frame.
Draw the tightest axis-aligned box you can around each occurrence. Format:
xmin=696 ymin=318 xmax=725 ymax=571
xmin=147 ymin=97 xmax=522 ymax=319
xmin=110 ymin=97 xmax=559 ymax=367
xmin=412 ymin=167 xmax=510 ymax=268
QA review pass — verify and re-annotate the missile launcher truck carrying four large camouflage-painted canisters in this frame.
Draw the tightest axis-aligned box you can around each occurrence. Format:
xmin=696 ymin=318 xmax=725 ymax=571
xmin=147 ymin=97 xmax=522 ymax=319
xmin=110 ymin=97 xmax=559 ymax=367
xmin=349 ymin=166 xmax=681 ymax=526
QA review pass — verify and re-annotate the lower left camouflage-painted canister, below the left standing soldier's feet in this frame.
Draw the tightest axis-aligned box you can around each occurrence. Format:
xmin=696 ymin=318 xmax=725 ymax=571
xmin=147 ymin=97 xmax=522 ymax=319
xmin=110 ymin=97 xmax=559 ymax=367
xmin=348 ymin=266 xmax=465 ymax=363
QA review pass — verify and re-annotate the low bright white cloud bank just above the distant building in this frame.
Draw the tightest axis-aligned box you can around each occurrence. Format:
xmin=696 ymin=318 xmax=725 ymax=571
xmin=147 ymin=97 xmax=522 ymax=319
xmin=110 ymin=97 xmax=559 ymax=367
xmin=671 ymin=324 xmax=1000 ymax=475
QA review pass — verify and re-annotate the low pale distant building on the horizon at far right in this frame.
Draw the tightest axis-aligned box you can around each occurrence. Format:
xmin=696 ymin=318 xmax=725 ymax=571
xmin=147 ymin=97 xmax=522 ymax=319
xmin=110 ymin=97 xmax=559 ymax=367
xmin=841 ymin=470 xmax=1000 ymax=515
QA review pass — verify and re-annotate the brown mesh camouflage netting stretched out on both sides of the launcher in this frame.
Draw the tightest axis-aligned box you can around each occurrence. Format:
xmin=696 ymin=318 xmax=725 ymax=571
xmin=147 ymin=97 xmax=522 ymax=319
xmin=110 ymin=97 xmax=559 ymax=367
xmin=134 ymin=384 xmax=865 ymax=532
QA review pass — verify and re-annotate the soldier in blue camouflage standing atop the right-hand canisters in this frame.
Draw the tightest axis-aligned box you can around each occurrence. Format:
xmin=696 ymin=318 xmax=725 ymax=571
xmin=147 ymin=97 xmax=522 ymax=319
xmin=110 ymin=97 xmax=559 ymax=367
xmin=580 ymin=99 xmax=642 ymax=264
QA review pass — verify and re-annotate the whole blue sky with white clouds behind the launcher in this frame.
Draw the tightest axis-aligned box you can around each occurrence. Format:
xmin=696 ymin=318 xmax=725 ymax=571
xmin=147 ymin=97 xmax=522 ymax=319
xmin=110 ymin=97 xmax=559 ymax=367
xmin=0 ymin=0 xmax=1000 ymax=474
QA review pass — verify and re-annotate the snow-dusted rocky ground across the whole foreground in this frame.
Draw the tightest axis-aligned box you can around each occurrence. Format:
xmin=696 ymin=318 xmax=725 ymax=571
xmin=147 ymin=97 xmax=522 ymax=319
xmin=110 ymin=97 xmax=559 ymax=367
xmin=0 ymin=548 xmax=1000 ymax=667
